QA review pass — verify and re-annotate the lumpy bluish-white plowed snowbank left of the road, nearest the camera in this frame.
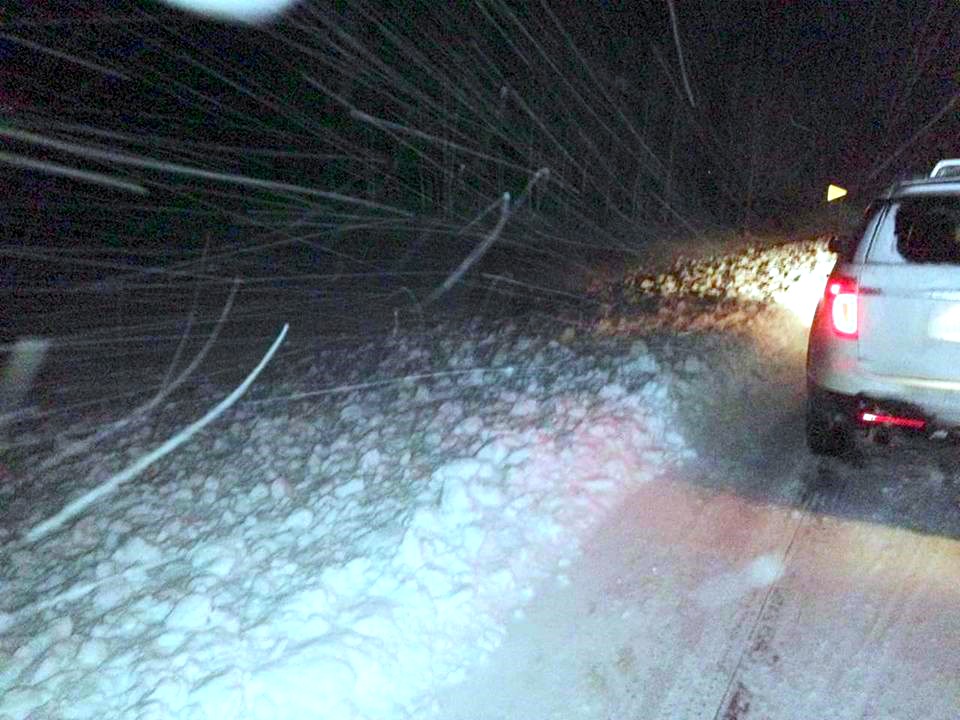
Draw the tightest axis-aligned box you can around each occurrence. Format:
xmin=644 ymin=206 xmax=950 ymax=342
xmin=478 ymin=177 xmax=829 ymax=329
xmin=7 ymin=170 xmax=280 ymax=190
xmin=0 ymin=324 xmax=687 ymax=720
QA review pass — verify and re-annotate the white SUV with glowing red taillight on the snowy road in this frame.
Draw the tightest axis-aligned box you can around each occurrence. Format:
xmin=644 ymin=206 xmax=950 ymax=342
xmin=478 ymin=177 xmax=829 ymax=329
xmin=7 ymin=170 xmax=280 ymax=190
xmin=807 ymin=160 xmax=960 ymax=454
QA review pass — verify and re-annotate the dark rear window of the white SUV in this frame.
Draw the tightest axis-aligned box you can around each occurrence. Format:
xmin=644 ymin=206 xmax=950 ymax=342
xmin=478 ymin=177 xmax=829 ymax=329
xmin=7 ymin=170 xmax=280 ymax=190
xmin=894 ymin=195 xmax=960 ymax=265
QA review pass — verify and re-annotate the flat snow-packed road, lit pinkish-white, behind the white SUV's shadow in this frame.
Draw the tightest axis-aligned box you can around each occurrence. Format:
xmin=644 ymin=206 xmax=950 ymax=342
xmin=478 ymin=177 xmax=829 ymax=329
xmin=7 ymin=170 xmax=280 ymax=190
xmin=442 ymin=472 xmax=960 ymax=720
